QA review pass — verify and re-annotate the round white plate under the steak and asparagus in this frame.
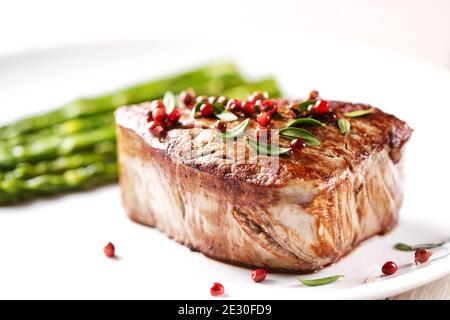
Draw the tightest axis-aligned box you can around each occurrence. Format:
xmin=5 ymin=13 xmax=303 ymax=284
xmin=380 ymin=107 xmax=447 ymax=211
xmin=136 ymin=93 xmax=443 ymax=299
xmin=0 ymin=35 xmax=450 ymax=299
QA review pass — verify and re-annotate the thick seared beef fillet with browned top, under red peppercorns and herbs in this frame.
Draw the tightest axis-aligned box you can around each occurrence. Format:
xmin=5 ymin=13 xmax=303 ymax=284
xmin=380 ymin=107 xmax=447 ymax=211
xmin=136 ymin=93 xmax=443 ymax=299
xmin=116 ymin=102 xmax=412 ymax=272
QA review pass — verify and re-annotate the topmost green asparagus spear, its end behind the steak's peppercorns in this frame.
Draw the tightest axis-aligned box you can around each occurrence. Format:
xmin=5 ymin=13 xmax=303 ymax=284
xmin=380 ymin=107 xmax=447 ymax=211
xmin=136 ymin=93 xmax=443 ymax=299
xmin=0 ymin=64 xmax=243 ymax=139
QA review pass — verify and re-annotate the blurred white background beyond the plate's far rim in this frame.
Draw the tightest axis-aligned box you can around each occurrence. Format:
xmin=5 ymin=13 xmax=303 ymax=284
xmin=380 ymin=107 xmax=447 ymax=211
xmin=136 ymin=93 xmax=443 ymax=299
xmin=0 ymin=0 xmax=450 ymax=72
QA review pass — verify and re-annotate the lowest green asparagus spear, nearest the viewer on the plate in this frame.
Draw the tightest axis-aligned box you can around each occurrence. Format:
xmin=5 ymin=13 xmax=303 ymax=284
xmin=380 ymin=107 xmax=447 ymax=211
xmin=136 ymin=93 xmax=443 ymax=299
xmin=0 ymin=162 xmax=117 ymax=205
